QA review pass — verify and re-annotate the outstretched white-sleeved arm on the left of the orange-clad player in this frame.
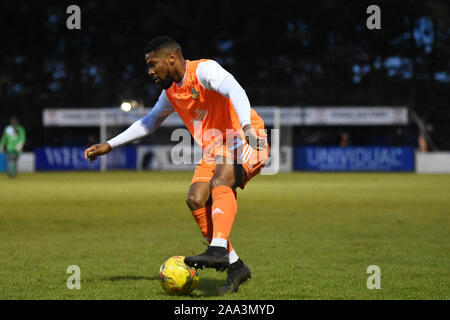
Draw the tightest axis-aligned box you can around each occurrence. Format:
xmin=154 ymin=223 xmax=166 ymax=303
xmin=84 ymin=90 xmax=174 ymax=163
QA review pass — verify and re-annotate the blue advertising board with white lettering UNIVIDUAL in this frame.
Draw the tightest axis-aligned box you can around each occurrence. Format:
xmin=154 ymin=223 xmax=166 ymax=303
xmin=294 ymin=147 xmax=414 ymax=171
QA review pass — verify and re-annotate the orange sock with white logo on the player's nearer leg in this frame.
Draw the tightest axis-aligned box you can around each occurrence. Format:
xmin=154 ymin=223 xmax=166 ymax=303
xmin=211 ymin=186 xmax=237 ymax=248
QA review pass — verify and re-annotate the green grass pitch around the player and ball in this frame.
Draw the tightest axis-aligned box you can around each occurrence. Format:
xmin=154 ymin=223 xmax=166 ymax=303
xmin=0 ymin=172 xmax=450 ymax=300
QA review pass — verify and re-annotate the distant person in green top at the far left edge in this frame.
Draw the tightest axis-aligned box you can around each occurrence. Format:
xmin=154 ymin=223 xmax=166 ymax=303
xmin=0 ymin=117 xmax=26 ymax=178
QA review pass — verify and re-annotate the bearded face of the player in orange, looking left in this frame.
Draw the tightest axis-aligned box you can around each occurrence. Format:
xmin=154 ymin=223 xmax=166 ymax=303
xmin=145 ymin=51 xmax=173 ymax=90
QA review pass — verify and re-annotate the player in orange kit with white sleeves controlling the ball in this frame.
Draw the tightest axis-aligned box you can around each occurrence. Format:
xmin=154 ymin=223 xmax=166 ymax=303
xmin=84 ymin=36 xmax=269 ymax=294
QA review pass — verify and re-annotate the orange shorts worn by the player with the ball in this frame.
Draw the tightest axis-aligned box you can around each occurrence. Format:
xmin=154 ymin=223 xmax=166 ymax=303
xmin=191 ymin=134 xmax=269 ymax=189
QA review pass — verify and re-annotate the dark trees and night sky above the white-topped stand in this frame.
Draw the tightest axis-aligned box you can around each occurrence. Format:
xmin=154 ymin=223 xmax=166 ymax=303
xmin=0 ymin=0 xmax=450 ymax=148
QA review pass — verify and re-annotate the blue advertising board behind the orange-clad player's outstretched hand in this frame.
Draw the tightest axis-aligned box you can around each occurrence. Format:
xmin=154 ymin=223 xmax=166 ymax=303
xmin=34 ymin=147 xmax=137 ymax=171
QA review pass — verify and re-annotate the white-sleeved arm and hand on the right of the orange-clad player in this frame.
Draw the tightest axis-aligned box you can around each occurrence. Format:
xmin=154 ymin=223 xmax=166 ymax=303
xmin=197 ymin=60 xmax=267 ymax=150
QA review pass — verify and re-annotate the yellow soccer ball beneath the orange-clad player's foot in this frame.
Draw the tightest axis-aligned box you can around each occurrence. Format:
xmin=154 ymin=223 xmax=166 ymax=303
xmin=159 ymin=256 xmax=200 ymax=295
